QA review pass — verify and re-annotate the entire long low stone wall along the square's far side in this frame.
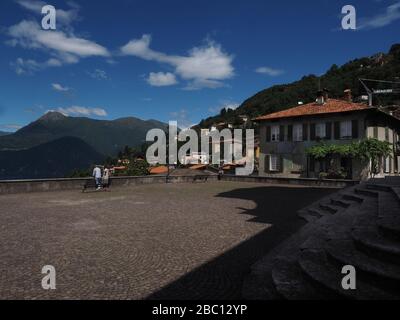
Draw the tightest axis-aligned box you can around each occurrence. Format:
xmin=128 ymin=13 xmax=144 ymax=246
xmin=0 ymin=175 xmax=359 ymax=195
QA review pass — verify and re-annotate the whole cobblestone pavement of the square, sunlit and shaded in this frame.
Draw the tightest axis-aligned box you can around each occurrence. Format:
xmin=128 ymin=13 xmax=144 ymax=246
xmin=0 ymin=182 xmax=334 ymax=299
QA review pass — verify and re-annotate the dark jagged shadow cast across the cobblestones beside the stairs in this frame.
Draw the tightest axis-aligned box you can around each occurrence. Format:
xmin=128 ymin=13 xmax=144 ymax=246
xmin=147 ymin=186 xmax=337 ymax=300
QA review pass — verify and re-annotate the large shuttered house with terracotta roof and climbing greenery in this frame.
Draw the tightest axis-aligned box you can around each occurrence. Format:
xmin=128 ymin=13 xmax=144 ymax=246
xmin=254 ymin=90 xmax=400 ymax=179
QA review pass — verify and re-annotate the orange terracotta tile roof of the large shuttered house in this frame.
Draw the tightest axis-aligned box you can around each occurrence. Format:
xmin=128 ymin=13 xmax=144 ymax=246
xmin=254 ymin=99 xmax=369 ymax=121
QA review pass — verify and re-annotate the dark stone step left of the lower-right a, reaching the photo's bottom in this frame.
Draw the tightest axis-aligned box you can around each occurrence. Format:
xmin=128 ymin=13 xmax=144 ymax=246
xmin=272 ymin=258 xmax=334 ymax=300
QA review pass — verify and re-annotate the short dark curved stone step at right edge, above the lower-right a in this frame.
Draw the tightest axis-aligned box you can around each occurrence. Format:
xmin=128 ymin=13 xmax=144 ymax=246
xmin=351 ymin=227 xmax=400 ymax=265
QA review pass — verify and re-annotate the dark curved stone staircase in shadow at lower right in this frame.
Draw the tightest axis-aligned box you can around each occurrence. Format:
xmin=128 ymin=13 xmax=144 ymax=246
xmin=243 ymin=177 xmax=400 ymax=300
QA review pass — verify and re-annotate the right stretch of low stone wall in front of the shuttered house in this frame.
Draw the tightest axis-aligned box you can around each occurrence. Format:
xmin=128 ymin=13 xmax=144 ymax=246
xmin=222 ymin=174 xmax=360 ymax=188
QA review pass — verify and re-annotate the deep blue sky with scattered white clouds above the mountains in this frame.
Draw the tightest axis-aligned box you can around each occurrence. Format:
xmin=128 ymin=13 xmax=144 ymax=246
xmin=0 ymin=0 xmax=400 ymax=131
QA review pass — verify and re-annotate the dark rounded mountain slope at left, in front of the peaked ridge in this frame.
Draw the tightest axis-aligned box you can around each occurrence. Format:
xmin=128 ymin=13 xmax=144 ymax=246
xmin=0 ymin=137 xmax=104 ymax=180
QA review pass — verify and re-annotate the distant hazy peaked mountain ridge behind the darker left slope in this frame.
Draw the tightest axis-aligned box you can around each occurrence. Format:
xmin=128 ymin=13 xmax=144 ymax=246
xmin=0 ymin=112 xmax=167 ymax=155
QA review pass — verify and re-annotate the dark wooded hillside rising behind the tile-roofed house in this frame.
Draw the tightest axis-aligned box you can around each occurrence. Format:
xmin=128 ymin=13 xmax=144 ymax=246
xmin=199 ymin=44 xmax=400 ymax=128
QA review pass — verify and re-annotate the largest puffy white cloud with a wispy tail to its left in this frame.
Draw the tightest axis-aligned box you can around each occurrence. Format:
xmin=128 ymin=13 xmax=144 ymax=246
xmin=121 ymin=35 xmax=234 ymax=89
